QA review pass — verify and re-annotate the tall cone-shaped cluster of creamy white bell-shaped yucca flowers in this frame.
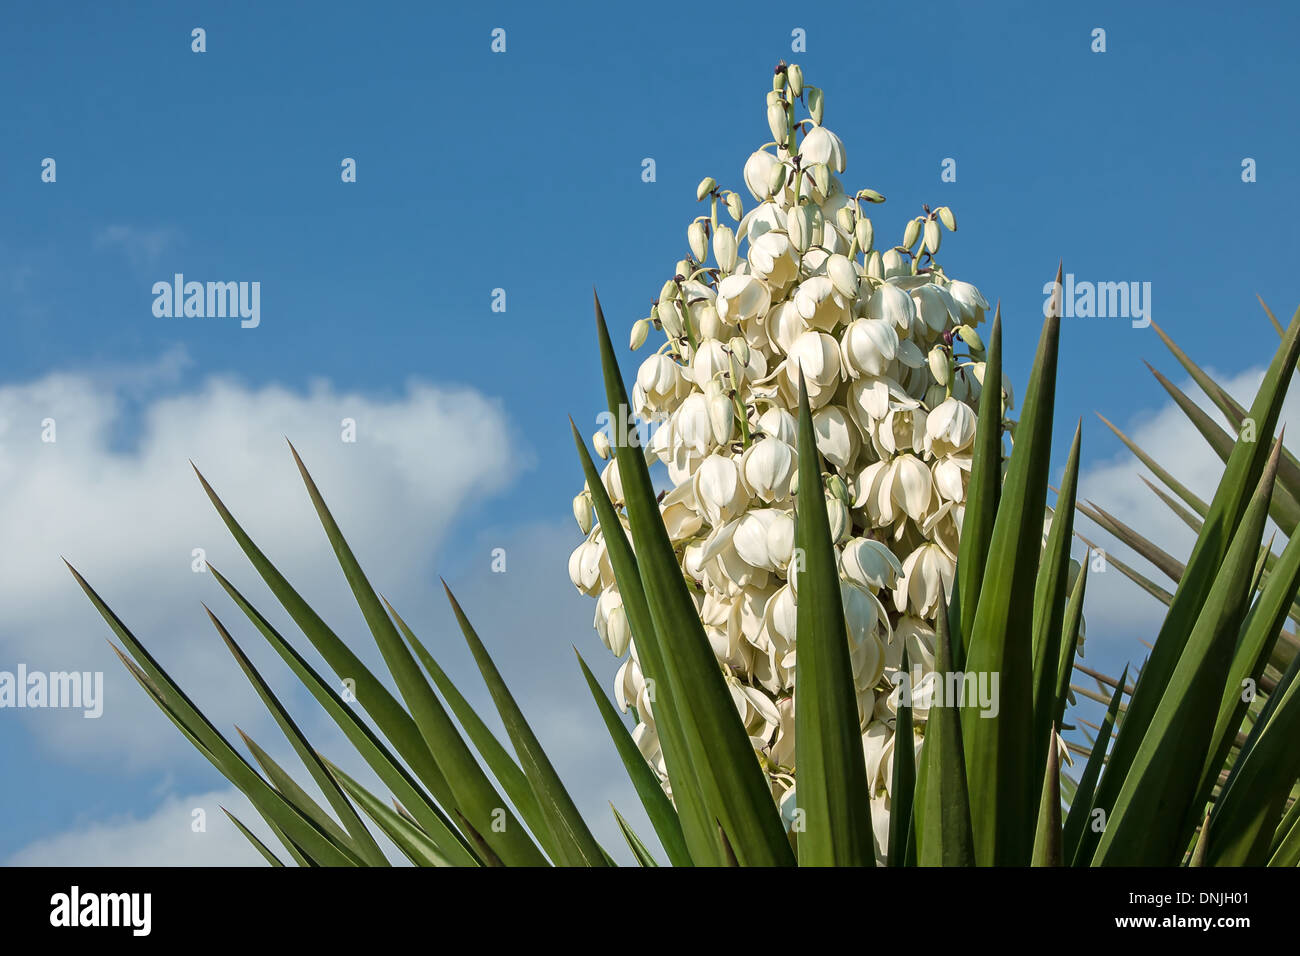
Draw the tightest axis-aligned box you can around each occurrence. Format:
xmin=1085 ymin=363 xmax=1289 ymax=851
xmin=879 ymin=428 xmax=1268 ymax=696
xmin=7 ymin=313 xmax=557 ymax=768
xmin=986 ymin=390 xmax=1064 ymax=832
xmin=569 ymin=64 xmax=1011 ymax=845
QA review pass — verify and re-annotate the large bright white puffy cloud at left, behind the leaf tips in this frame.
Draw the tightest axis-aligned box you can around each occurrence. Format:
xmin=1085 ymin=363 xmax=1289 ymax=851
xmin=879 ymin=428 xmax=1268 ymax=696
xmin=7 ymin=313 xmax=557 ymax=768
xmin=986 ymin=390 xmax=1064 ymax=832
xmin=0 ymin=355 xmax=521 ymax=767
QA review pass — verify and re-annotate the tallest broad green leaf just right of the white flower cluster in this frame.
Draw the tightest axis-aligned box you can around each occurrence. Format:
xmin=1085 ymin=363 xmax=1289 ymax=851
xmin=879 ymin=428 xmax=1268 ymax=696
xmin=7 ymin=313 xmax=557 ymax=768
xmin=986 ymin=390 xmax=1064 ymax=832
xmin=962 ymin=286 xmax=1061 ymax=866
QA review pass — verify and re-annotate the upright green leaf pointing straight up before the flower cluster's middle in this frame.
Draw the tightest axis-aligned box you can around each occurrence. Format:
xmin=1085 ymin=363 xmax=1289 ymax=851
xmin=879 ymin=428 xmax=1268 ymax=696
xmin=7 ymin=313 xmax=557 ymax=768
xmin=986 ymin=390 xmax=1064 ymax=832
xmin=792 ymin=372 xmax=875 ymax=866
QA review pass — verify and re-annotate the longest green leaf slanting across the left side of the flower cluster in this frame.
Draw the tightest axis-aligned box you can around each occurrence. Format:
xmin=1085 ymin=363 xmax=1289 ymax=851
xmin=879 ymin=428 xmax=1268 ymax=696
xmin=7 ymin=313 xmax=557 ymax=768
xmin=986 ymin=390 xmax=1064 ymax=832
xmin=593 ymin=290 xmax=794 ymax=866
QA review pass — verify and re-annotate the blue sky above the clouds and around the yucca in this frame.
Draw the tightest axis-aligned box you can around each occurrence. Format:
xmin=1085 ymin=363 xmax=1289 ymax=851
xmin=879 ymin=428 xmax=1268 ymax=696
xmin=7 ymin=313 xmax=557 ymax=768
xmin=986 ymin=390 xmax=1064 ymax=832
xmin=0 ymin=1 xmax=1300 ymax=860
